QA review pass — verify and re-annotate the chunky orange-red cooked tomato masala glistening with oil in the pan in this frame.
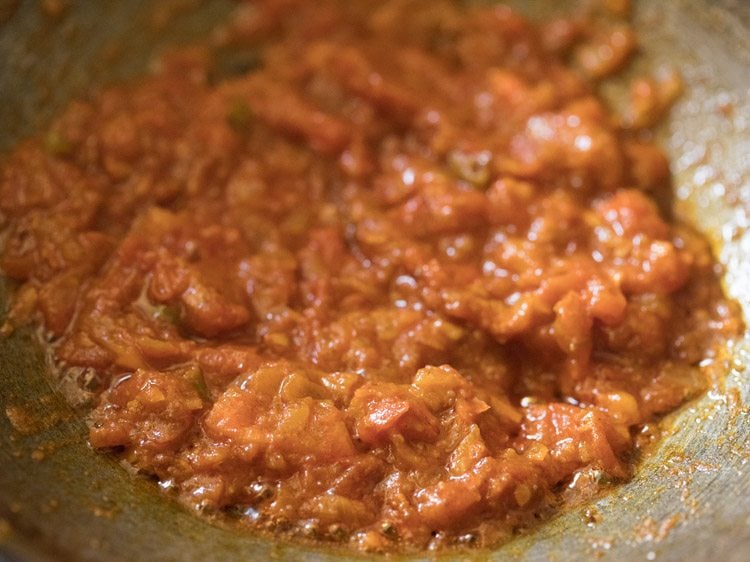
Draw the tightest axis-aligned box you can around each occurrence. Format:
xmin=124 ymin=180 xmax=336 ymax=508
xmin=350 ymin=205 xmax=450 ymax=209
xmin=0 ymin=0 xmax=740 ymax=550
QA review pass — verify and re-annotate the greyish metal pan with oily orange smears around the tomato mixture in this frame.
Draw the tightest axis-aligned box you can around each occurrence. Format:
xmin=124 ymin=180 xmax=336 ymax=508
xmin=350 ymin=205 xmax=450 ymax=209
xmin=0 ymin=0 xmax=750 ymax=562
